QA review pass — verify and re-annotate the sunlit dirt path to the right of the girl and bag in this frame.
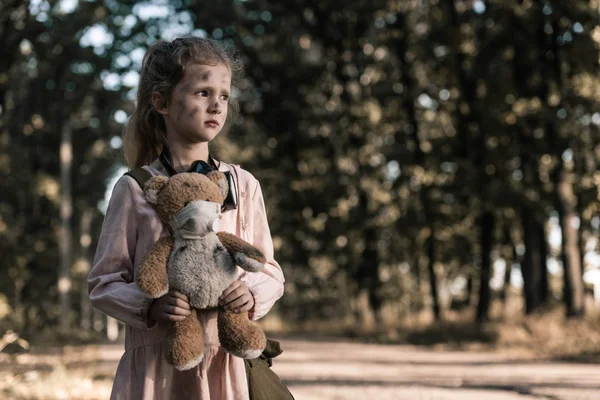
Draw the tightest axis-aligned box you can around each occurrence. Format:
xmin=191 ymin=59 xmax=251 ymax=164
xmin=274 ymin=340 xmax=600 ymax=400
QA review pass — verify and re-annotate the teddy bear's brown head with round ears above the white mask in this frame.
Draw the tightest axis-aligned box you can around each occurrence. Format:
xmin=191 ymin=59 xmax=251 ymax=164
xmin=144 ymin=171 xmax=229 ymax=223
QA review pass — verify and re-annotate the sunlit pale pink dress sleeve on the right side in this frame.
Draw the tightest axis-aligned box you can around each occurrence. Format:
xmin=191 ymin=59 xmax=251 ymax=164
xmin=242 ymin=182 xmax=285 ymax=320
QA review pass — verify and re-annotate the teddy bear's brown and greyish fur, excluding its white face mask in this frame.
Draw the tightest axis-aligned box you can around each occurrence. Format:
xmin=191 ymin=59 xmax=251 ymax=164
xmin=136 ymin=171 xmax=266 ymax=370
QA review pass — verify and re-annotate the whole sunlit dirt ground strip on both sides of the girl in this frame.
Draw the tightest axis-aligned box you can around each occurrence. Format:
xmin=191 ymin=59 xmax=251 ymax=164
xmin=0 ymin=339 xmax=600 ymax=400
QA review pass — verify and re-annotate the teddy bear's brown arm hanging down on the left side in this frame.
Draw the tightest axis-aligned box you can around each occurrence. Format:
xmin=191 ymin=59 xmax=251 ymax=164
xmin=135 ymin=236 xmax=173 ymax=299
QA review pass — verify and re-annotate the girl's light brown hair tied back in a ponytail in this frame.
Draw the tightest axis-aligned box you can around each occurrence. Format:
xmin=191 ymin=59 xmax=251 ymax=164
xmin=123 ymin=37 xmax=244 ymax=168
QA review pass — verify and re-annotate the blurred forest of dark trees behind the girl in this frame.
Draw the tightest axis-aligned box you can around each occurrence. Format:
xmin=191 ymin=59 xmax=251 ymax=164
xmin=0 ymin=0 xmax=600 ymax=344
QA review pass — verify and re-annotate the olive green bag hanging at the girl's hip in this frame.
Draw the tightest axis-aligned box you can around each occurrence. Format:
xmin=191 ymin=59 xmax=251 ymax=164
xmin=244 ymin=339 xmax=294 ymax=400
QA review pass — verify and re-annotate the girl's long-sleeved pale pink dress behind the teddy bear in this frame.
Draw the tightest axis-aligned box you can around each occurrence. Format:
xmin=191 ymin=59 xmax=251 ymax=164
xmin=88 ymin=163 xmax=284 ymax=400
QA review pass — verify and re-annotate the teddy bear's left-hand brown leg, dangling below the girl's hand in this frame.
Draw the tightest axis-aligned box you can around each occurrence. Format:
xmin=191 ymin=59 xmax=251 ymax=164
xmin=167 ymin=308 xmax=204 ymax=371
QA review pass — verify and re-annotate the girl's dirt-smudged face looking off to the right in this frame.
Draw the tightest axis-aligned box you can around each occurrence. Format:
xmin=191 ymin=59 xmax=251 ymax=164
xmin=158 ymin=63 xmax=231 ymax=144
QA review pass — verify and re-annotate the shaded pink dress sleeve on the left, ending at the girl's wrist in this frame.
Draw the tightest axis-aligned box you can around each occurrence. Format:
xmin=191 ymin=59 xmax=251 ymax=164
xmin=88 ymin=177 xmax=157 ymax=329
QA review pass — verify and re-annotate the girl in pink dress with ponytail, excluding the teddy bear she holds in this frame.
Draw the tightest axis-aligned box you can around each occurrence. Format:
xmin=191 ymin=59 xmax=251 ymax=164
xmin=88 ymin=37 xmax=284 ymax=400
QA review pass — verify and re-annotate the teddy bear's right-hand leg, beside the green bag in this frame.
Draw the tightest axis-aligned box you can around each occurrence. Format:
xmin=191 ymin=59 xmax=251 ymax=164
xmin=217 ymin=310 xmax=267 ymax=358
